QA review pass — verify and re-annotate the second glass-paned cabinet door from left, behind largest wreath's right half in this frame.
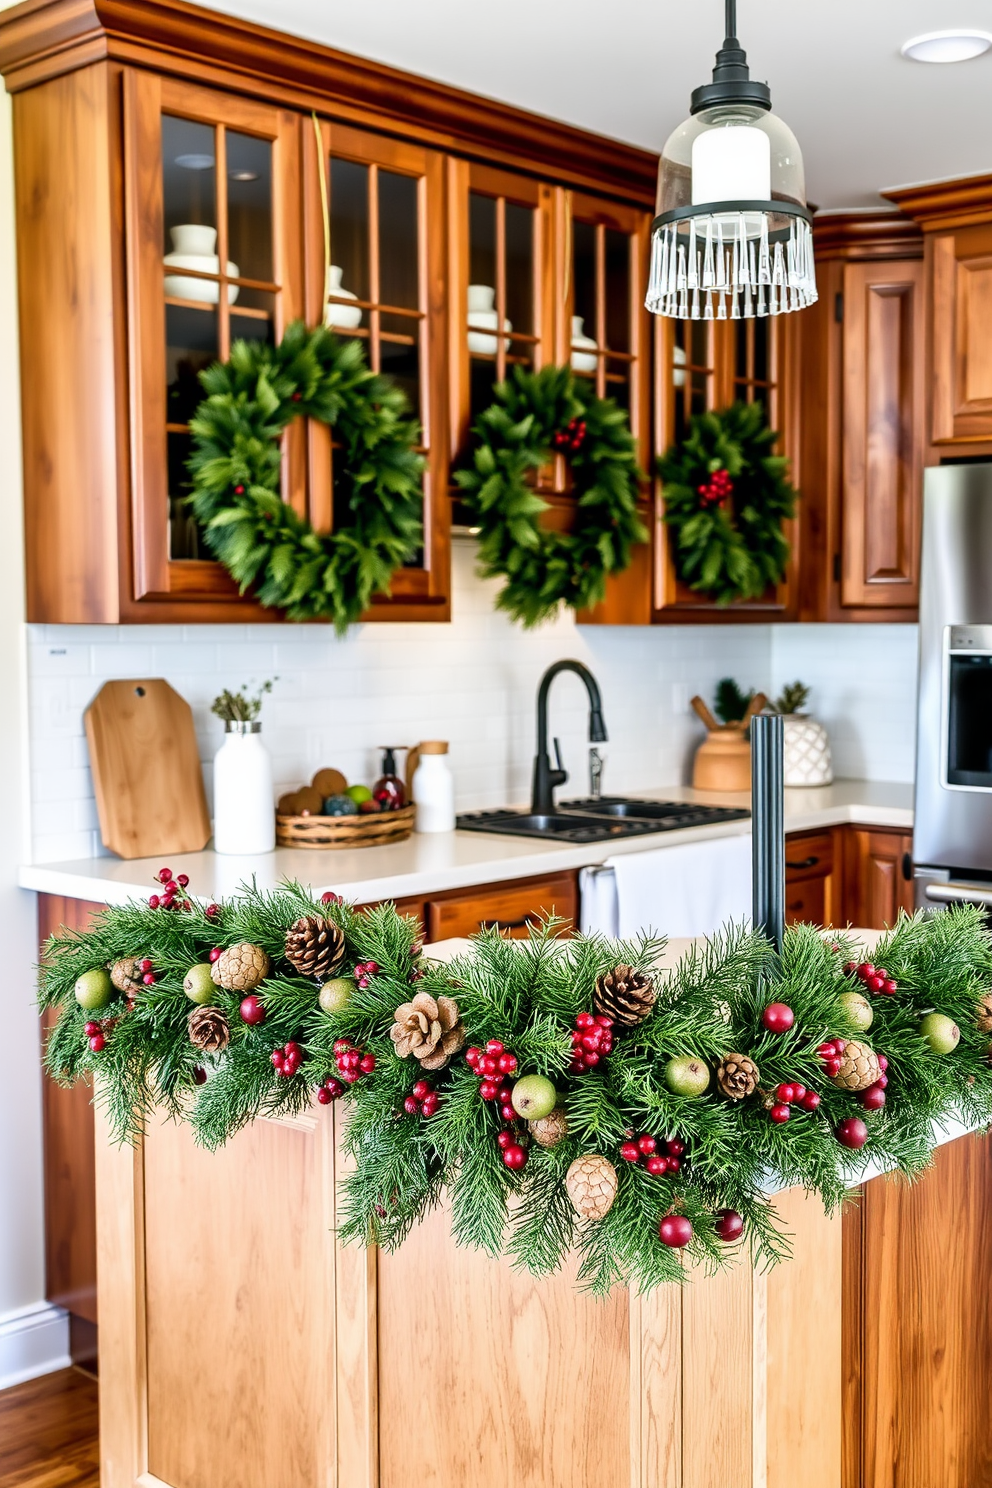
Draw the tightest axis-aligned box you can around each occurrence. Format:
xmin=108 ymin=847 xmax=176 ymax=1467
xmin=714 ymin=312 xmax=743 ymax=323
xmin=303 ymin=121 xmax=451 ymax=619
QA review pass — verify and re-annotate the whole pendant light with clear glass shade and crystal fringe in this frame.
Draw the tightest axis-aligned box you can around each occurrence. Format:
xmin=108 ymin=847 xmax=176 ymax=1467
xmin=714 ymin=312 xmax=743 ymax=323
xmin=645 ymin=0 xmax=817 ymax=320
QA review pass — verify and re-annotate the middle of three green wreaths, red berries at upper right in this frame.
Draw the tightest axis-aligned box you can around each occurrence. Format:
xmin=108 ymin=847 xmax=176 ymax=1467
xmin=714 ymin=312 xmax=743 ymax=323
xmin=455 ymin=366 xmax=647 ymax=626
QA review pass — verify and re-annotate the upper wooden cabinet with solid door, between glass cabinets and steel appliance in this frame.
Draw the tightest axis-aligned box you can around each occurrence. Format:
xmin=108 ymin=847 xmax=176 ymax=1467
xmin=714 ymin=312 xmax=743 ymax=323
xmin=799 ymin=213 xmax=927 ymax=620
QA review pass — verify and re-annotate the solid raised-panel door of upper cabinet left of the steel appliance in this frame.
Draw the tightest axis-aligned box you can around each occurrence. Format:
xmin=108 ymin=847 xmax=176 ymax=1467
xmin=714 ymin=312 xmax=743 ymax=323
xmin=844 ymin=259 xmax=928 ymax=609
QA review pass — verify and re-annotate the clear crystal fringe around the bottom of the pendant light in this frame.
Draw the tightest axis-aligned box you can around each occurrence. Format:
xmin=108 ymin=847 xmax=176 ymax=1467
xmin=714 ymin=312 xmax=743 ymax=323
xmin=644 ymin=210 xmax=817 ymax=320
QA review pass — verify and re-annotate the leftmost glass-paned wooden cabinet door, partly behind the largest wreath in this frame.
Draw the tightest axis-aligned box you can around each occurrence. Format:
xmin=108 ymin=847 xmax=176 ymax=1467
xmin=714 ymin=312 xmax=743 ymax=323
xmin=125 ymin=73 xmax=305 ymax=607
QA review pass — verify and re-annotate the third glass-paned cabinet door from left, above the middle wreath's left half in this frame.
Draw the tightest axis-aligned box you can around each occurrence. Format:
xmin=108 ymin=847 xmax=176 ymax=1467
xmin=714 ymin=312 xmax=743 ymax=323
xmin=448 ymin=159 xmax=555 ymax=455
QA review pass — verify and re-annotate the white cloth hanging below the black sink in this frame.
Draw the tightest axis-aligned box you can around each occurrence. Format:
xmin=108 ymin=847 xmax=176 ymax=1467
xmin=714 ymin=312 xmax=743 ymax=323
xmin=580 ymin=833 xmax=751 ymax=940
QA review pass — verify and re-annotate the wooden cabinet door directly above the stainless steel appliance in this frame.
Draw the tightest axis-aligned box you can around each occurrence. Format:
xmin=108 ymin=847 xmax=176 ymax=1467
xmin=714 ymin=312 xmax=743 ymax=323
xmin=930 ymin=226 xmax=992 ymax=445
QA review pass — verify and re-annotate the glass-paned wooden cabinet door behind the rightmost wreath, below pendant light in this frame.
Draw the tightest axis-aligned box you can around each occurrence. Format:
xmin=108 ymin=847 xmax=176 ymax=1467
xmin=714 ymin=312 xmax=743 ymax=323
xmin=653 ymin=315 xmax=799 ymax=623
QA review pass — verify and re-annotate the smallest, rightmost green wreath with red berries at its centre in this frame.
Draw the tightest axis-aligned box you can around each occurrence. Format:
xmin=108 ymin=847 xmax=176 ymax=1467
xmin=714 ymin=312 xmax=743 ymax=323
xmin=657 ymin=403 xmax=799 ymax=604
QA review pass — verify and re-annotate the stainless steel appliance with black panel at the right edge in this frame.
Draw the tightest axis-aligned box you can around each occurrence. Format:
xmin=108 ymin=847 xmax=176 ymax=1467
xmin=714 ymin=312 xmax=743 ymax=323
xmin=913 ymin=461 xmax=992 ymax=906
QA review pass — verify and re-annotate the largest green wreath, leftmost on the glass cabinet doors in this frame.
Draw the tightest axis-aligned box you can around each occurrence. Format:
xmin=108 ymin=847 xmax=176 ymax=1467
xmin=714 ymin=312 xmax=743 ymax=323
xmin=187 ymin=321 xmax=424 ymax=635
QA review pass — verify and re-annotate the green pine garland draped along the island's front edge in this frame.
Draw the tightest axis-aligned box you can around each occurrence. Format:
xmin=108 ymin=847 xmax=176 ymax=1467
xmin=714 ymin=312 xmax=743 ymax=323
xmin=40 ymin=884 xmax=992 ymax=1293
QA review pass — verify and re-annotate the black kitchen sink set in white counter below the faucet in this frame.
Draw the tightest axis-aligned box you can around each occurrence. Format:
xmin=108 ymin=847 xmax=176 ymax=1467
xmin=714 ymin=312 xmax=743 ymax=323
xmin=458 ymin=796 xmax=751 ymax=842
